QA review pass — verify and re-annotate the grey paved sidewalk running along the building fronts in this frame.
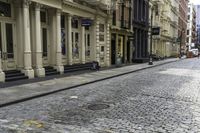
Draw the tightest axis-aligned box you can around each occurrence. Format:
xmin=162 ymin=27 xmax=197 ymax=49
xmin=0 ymin=58 xmax=180 ymax=107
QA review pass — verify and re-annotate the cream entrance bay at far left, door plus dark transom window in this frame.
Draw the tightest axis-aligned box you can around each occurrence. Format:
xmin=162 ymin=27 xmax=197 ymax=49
xmin=0 ymin=1 xmax=17 ymax=71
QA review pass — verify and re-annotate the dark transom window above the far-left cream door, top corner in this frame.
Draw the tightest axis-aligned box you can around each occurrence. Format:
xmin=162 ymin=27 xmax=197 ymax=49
xmin=0 ymin=1 xmax=11 ymax=17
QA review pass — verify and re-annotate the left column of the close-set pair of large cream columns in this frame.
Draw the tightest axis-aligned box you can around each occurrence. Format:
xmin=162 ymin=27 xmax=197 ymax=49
xmin=23 ymin=0 xmax=34 ymax=78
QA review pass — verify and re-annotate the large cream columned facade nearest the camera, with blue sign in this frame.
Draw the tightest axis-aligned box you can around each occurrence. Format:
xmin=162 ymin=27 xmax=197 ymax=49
xmin=0 ymin=0 xmax=110 ymax=82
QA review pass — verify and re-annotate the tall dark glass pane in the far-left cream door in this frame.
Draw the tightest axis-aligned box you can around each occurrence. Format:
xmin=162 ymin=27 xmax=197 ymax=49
xmin=6 ymin=24 xmax=14 ymax=58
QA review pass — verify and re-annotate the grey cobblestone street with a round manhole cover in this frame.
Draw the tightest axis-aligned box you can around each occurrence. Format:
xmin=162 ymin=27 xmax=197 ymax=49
xmin=0 ymin=58 xmax=200 ymax=133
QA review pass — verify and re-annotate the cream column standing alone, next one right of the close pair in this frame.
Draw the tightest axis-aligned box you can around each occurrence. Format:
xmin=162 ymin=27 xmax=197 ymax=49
xmin=55 ymin=10 xmax=64 ymax=74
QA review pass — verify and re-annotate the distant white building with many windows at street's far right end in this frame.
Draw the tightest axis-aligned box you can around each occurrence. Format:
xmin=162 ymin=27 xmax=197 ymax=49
xmin=186 ymin=3 xmax=196 ymax=50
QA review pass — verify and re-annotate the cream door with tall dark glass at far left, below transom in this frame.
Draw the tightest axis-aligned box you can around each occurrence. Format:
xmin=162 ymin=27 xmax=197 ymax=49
xmin=0 ymin=21 xmax=16 ymax=71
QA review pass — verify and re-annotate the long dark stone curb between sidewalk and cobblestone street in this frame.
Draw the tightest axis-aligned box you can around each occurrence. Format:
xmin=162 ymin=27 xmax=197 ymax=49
xmin=0 ymin=59 xmax=184 ymax=108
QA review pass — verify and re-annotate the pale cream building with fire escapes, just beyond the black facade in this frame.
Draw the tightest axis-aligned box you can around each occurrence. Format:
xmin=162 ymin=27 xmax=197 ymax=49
xmin=149 ymin=0 xmax=179 ymax=58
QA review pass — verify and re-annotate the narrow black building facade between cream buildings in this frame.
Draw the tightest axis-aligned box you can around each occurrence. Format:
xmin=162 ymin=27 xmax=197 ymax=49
xmin=133 ymin=0 xmax=149 ymax=62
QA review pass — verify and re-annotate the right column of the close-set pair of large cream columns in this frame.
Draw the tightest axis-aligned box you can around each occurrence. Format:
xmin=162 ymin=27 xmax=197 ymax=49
xmin=35 ymin=4 xmax=45 ymax=77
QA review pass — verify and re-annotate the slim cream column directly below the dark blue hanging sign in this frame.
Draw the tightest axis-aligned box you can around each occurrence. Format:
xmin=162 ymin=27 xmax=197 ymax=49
xmin=81 ymin=26 xmax=85 ymax=64
